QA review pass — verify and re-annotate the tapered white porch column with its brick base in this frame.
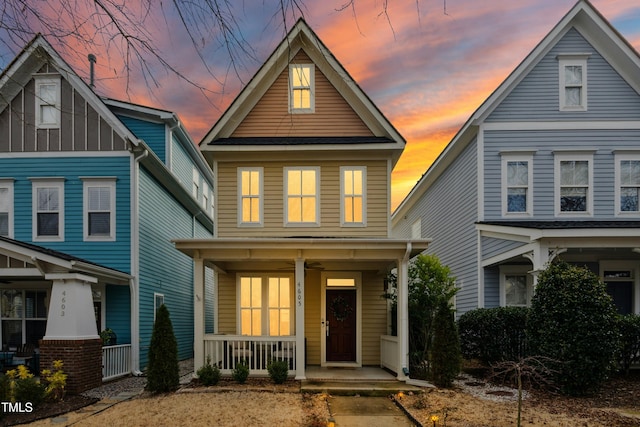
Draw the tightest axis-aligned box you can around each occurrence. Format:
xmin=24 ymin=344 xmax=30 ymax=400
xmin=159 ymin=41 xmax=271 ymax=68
xmin=40 ymin=273 xmax=102 ymax=393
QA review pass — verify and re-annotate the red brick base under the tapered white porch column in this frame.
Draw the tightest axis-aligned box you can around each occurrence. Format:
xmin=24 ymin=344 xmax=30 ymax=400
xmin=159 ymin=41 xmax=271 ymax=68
xmin=40 ymin=339 xmax=102 ymax=394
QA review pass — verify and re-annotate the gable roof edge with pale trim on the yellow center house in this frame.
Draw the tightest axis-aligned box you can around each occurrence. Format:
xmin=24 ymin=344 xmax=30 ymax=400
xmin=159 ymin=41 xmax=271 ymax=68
xmin=200 ymin=18 xmax=405 ymax=162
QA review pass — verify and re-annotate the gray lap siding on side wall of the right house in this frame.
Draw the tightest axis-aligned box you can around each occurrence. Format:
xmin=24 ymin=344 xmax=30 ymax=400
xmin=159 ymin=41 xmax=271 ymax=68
xmin=393 ymin=140 xmax=479 ymax=316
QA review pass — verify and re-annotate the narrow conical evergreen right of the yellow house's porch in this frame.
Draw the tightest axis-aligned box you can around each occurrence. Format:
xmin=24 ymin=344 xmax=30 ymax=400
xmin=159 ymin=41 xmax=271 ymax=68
xmin=431 ymin=301 xmax=461 ymax=387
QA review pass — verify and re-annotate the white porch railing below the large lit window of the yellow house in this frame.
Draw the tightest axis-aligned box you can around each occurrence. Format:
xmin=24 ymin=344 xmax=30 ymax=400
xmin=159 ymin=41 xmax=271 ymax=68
xmin=202 ymin=334 xmax=296 ymax=376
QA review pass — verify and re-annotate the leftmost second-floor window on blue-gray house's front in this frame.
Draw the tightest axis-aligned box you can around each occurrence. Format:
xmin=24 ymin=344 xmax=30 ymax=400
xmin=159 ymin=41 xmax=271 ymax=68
xmin=502 ymin=153 xmax=533 ymax=216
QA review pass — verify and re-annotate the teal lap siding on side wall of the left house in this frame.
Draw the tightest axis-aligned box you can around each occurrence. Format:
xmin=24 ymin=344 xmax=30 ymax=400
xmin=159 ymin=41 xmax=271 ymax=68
xmin=139 ymin=168 xmax=193 ymax=367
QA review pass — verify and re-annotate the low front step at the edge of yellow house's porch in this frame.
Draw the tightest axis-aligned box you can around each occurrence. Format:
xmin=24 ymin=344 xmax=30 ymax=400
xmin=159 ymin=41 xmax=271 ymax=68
xmin=300 ymin=380 xmax=423 ymax=396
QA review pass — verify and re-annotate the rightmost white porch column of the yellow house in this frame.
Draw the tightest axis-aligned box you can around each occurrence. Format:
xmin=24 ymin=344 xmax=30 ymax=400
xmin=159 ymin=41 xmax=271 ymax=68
xmin=397 ymin=243 xmax=411 ymax=381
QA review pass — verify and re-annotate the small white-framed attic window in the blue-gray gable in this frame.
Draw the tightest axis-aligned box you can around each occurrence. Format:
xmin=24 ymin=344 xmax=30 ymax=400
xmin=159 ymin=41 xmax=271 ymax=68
xmin=558 ymin=54 xmax=589 ymax=111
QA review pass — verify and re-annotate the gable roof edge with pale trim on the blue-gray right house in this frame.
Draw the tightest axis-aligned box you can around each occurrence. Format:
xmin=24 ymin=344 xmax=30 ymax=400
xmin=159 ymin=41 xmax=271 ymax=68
xmin=392 ymin=0 xmax=640 ymax=223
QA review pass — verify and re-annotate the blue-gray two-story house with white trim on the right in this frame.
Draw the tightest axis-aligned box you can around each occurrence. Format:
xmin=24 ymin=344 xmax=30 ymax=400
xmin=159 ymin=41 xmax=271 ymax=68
xmin=392 ymin=0 xmax=640 ymax=320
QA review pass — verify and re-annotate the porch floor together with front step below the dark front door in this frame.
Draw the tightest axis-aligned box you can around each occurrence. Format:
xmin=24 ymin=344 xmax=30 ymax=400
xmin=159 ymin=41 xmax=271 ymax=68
xmin=300 ymin=366 xmax=421 ymax=396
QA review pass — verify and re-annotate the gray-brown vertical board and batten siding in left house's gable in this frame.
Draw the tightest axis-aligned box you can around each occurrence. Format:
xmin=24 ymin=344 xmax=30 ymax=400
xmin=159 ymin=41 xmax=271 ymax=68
xmin=0 ymin=67 xmax=127 ymax=153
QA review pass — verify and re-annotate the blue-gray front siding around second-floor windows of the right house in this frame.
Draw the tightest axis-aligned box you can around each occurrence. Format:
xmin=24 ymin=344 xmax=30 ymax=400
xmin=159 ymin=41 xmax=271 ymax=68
xmin=484 ymin=129 xmax=640 ymax=221
